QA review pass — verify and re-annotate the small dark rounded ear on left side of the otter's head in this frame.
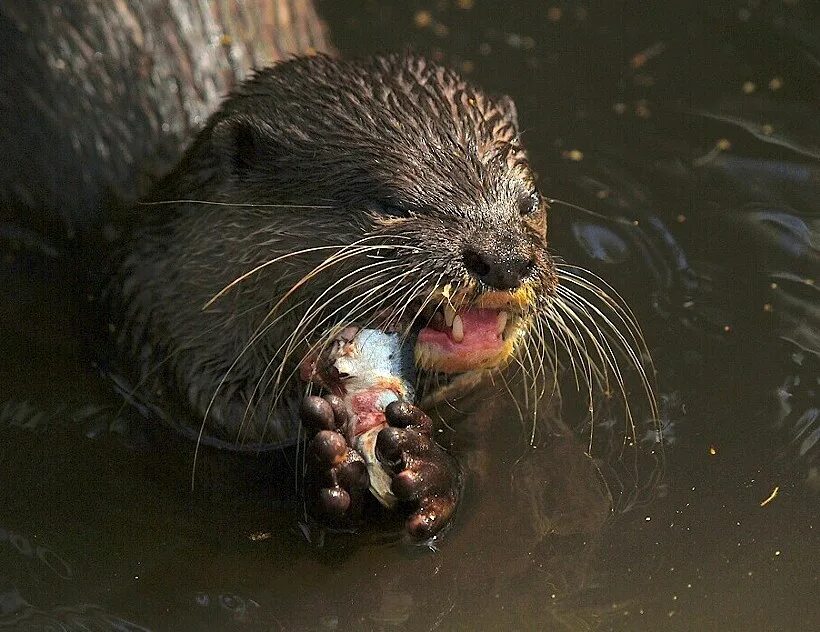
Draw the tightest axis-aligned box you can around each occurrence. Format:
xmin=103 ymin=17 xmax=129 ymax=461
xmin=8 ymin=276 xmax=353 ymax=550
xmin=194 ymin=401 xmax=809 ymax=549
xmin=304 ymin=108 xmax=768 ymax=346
xmin=211 ymin=114 xmax=273 ymax=179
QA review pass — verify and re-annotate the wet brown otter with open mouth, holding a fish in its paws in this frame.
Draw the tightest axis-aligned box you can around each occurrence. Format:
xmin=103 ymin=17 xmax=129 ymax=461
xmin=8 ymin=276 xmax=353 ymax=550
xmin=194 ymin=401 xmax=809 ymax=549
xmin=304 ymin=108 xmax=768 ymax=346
xmin=106 ymin=54 xmax=557 ymax=538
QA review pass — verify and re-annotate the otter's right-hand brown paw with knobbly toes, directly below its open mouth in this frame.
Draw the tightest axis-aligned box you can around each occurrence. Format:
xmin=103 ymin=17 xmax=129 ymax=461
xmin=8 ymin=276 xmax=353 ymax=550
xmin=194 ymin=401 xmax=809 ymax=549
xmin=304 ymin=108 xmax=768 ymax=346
xmin=376 ymin=402 xmax=461 ymax=540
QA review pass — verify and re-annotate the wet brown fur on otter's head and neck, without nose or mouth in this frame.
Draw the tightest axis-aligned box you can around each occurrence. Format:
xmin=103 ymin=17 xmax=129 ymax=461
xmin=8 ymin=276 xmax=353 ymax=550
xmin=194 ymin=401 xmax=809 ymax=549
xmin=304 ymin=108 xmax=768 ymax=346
xmin=110 ymin=55 xmax=555 ymax=444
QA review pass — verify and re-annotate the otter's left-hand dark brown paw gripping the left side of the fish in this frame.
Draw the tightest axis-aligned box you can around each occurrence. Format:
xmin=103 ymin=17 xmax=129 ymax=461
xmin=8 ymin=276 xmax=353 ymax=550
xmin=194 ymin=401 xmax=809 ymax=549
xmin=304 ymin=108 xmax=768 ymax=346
xmin=300 ymin=395 xmax=368 ymax=522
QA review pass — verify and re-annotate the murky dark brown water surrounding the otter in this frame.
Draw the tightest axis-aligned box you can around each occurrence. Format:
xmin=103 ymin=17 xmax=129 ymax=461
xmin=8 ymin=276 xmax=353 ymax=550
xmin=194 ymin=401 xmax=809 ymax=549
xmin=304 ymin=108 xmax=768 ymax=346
xmin=0 ymin=0 xmax=820 ymax=630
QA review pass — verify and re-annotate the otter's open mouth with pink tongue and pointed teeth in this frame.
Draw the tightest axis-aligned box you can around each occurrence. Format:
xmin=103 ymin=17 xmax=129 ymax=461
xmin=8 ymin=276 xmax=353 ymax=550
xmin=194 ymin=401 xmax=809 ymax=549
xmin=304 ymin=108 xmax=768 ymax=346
xmin=414 ymin=288 xmax=531 ymax=373
